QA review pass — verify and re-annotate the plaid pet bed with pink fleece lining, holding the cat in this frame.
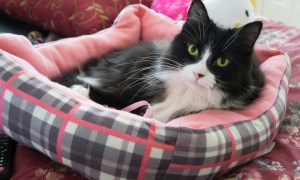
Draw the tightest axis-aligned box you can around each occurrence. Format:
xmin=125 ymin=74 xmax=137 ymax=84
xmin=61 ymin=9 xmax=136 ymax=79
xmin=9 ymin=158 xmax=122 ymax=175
xmin=0 ymin=5 xmax=290 ymax=179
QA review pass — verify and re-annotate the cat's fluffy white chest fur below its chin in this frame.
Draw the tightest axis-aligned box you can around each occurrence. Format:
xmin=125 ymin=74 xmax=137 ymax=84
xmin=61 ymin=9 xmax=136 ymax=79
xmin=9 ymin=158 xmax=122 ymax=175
xmin=152 ymin=73 xmax=223 ymax=122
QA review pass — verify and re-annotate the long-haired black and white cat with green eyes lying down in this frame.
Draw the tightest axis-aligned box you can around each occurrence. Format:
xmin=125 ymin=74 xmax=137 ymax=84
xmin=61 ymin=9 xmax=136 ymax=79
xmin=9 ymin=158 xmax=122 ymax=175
xmin=57 ymin=0 xmax=264 ymax=122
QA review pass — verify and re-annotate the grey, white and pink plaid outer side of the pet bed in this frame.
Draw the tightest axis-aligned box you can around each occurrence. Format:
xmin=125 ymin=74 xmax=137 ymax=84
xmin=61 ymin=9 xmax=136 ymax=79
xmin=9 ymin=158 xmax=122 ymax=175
xmin=0 ymin=47 xmax=290 ymax=179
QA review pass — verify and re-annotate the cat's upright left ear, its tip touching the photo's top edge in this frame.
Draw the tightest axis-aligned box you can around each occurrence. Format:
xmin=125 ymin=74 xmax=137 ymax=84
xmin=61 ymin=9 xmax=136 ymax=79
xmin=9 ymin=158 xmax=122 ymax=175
xmin=187 ymin=0 xmax=210 ymax=24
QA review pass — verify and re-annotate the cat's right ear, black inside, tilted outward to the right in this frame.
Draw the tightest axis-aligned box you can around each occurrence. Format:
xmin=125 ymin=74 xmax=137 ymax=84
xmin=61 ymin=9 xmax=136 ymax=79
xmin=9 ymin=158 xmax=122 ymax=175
xmin=238 ymin=21 xmax=263 ymax=49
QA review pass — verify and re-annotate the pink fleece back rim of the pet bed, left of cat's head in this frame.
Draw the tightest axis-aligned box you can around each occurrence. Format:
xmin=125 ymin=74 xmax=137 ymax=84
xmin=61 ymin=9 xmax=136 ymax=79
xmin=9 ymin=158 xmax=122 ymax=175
xmin=0 ymin=6 xmax=180 ymax=77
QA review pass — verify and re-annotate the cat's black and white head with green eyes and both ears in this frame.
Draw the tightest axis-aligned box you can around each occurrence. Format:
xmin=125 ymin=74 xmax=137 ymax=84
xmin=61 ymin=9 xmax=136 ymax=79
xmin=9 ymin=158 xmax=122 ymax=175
xmin=157 ymin=0 xmax=262 ymax=108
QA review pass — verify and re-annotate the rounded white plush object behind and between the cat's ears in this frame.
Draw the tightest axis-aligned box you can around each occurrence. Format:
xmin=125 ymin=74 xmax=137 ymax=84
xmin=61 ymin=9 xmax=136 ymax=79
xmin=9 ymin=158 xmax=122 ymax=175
xmin=203 ymin=0 xmax=254 ymax=28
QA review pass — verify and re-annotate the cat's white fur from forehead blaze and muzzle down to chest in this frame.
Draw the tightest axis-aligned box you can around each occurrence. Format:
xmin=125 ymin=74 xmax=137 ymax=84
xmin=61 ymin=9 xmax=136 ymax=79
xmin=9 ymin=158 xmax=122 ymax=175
xmin=152 ymin=48 xmax=223 ymax=122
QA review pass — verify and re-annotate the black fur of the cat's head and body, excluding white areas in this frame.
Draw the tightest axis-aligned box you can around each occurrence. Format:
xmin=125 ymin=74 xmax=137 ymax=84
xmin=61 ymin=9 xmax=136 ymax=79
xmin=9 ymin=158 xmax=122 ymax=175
xmin=55 ymin=0 xmax=264 ymax=116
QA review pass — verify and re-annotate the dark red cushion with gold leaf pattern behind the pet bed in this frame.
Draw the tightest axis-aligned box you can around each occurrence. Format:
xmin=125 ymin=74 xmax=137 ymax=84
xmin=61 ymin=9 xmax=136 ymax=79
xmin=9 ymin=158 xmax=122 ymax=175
xmin=0 ymin=0 xmax=152 ymax=36
